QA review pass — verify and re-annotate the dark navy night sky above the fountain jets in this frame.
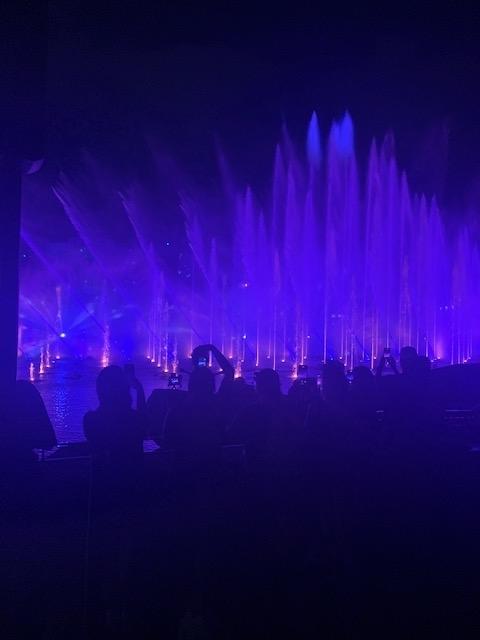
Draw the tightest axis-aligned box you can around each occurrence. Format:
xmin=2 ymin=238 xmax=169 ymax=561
xmin=10 ymin=0 xmax=480 ymax=205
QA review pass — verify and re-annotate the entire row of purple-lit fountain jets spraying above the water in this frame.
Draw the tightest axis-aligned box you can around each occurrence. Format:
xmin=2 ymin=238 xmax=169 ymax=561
xmin=16 ymin=114 xmax=480 ymax=376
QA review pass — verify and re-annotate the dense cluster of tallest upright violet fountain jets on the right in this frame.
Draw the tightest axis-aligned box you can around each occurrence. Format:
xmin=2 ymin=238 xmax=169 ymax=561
xmin=181 ymin=114 xmax=479 ymax=370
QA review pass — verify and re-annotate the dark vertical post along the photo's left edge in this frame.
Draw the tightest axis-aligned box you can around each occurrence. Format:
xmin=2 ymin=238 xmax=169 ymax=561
xmin=0 ymin=0 xmax=47 ymax=436
